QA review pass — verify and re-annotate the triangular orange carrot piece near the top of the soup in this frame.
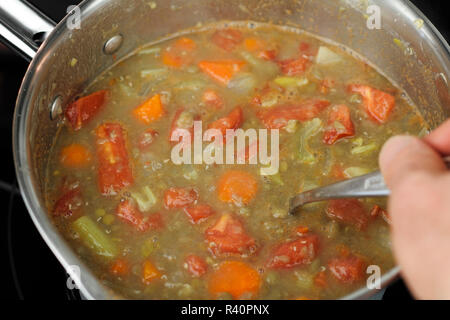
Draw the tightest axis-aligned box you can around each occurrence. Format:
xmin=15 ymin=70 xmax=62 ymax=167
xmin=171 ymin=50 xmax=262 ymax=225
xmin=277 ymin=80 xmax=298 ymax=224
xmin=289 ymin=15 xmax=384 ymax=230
xmin=198 ymin=60 xmax=245 ymax=86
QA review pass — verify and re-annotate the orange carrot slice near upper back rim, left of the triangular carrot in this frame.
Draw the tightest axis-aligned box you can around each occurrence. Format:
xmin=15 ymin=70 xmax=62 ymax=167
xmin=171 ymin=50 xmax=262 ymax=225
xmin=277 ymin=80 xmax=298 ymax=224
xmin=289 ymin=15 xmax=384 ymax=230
xmin=162 ymin=37 xmax=196 ymax=68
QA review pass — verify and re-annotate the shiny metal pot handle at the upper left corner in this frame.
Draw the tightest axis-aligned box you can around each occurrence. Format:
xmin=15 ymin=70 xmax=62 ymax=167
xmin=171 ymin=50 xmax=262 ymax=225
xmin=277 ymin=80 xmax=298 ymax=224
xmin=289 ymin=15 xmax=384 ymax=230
xmin=0 ymin=0 xmax=56 ymax=61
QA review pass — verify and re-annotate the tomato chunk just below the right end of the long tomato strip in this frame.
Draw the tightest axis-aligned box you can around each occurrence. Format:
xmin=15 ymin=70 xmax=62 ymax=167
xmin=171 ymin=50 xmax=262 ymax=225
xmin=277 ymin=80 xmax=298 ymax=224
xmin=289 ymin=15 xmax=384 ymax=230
xmin=323 ymin=105 xmax=355 ymax=145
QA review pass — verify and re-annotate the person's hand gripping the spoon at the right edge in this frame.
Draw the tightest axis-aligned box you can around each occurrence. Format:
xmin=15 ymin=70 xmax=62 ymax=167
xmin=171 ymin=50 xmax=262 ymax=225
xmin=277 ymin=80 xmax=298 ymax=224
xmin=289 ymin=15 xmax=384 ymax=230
xmin=380 ymin=121 xmax=450 ymax=299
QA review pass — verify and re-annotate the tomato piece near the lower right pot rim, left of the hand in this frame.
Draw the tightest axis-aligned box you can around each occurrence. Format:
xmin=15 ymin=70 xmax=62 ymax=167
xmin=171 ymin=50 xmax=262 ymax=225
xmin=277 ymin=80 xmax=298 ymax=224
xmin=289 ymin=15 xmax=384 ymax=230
xmin=328 ymin=255 xmax=366 ymax=283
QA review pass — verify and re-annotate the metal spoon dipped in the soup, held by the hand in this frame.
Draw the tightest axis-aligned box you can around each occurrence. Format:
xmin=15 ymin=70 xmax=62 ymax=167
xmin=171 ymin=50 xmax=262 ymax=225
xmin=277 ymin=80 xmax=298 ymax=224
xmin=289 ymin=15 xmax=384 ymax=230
xmin=289 ymin=157 xmax=450 ymax=215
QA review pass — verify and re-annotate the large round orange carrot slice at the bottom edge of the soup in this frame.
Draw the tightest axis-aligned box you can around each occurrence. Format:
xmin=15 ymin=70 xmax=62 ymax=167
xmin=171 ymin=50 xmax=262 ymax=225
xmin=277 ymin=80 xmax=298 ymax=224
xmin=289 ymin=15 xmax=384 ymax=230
xmin=208 ymin=261 xmax=261 ymax=300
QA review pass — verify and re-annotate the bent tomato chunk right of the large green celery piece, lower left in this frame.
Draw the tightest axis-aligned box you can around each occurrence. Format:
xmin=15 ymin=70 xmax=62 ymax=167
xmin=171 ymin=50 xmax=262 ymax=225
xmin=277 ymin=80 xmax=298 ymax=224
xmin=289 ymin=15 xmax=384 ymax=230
xmin=116 ymin=200 xmax=164 ymax=232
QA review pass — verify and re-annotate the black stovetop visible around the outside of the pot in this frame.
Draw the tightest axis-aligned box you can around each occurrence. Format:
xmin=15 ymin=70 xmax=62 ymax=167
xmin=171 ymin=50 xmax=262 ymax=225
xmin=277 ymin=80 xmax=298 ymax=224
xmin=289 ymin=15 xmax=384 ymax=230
xmin=0 ymin=0 xmax=450 ymax=300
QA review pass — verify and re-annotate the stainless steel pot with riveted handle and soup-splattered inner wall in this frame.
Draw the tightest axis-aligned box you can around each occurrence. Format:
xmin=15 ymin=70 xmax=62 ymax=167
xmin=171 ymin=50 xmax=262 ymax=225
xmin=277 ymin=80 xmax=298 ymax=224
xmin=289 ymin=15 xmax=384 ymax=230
xmin=0 ymin=0 xmax=450 ymax=299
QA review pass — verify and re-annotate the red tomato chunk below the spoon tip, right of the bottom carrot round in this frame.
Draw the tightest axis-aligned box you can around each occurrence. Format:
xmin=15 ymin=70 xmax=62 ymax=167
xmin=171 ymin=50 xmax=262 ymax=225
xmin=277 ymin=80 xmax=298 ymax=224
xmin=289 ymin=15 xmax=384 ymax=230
xmin=267 ymin=235 xmax=319 ymax=269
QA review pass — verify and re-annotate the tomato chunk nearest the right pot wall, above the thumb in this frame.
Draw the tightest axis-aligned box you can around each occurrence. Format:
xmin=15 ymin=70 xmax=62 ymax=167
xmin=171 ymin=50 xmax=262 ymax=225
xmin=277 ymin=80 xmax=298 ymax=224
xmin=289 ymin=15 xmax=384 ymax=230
xmin=348 ymin=84 xmax=395 ymax=124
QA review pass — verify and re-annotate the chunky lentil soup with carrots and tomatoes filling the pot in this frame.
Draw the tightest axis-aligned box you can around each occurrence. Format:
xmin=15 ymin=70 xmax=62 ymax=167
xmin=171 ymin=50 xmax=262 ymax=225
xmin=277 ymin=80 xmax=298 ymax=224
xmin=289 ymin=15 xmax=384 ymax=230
xmin=46 ymin=24 xmax=426 ymax=299
